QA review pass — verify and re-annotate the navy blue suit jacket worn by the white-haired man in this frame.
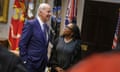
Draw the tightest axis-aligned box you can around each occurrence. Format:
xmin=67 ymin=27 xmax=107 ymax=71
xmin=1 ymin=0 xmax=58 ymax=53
xmin=19 ymin=19 xmax=49 ymax=68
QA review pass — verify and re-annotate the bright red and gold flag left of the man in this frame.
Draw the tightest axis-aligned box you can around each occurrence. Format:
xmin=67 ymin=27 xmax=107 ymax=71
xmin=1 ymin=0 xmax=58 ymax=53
xmin=9 ymin=0 xmax=25 ymax=50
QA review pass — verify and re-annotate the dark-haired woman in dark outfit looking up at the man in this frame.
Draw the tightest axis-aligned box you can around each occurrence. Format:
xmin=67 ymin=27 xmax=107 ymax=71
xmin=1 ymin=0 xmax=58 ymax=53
xmin=50 ymin=23 xmax=81 ymax=72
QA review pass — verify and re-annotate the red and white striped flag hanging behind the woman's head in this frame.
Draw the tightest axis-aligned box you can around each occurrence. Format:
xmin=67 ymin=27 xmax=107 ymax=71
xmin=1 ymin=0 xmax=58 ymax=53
xmin=65 ymin=0 xmax=77 ymax=25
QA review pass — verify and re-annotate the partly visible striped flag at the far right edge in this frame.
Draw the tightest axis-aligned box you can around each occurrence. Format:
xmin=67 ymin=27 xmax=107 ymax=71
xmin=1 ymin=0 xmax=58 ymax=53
xmin=112 ymin=10 xmax=120 ymax=49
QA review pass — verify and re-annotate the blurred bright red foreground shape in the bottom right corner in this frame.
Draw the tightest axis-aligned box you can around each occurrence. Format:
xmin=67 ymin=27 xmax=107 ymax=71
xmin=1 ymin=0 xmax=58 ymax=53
xmin=66 ymin=51 xmax=120 ymax=72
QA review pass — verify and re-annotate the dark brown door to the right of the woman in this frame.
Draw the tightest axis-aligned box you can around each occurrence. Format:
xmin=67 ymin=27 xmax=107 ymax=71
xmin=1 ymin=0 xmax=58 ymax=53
xmin=81 ymin=1 xmax=120 ymax=55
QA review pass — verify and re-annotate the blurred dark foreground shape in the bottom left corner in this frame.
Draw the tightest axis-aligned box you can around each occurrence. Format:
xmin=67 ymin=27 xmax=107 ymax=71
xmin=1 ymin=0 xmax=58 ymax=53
xmin=0 ymin=45 xmax=27 ymax=72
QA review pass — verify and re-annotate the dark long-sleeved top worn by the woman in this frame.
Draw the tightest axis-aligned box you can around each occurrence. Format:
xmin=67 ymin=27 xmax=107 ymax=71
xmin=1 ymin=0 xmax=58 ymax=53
xmin=49 ymin=36 xmax=81 ymax=72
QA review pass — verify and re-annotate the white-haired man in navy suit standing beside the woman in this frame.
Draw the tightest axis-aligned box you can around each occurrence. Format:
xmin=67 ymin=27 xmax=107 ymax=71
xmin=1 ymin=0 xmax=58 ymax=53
xmin=19 ymin=3 xmax=51 ymax=72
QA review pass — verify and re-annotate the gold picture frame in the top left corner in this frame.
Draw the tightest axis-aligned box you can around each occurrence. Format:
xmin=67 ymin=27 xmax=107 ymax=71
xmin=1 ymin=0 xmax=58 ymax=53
xmin=0 ymin=0 xmax=9 ymax=23
